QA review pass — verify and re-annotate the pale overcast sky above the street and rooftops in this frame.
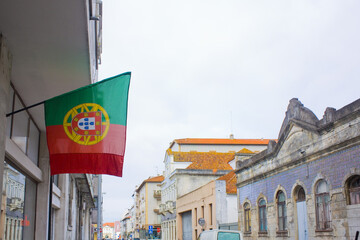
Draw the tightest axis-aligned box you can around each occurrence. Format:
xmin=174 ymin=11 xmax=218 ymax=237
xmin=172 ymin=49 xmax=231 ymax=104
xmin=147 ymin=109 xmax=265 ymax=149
xmin=99 ymin=0 xmax=360 ymax=222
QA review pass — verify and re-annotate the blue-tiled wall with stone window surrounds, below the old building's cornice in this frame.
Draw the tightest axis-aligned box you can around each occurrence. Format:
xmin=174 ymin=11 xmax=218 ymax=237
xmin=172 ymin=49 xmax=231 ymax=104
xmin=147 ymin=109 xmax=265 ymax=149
xmin=238 ymin=145 xmax=360 ymax=239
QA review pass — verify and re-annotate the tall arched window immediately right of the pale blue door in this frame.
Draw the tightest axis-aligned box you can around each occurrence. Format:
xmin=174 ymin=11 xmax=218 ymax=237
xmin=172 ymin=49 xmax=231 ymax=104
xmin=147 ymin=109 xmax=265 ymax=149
xmin=315 ymin=180 xmax=331 ymax=230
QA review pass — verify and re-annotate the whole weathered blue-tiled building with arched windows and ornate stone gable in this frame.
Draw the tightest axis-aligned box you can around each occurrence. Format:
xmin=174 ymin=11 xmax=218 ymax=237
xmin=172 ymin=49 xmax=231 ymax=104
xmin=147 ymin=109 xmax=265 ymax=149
xmin=236 ymin=99 xmax=360 ymax=239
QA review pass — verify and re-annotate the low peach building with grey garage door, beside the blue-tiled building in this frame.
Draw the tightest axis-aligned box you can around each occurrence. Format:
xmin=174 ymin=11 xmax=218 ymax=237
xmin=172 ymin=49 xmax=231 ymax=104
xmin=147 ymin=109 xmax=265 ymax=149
xmin=176 ymin=171 xmax=238 ymax=240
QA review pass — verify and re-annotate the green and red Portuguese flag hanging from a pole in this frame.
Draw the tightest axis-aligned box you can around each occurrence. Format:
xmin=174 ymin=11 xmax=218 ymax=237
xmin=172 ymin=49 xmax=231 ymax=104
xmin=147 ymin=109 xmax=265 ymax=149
xmin=45 ymin=72 xmax=131 ymax=177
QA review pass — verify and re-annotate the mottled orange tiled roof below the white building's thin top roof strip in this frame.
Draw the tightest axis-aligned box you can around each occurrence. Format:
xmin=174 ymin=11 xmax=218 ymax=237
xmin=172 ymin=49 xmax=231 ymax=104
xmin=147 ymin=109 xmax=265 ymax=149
xmin=172 ymin=151 xmax=235 ymax=170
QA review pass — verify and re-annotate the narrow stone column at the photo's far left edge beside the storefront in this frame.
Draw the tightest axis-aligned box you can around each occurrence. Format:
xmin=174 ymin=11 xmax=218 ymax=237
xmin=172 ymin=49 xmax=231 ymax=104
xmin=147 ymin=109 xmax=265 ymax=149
xmin=0 ymin=34 xmax=12 ymax=240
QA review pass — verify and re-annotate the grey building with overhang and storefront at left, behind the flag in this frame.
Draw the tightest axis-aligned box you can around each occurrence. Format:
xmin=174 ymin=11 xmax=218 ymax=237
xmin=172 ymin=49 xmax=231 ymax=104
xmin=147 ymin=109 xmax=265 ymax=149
xmin=0 ymin=0 xmax=102 ymax=239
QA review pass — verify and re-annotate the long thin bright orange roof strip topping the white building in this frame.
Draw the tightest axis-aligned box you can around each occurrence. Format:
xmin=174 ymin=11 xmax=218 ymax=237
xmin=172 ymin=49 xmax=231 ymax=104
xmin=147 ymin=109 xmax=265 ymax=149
xmin=174 ymin=138 xmax=272 ymax=145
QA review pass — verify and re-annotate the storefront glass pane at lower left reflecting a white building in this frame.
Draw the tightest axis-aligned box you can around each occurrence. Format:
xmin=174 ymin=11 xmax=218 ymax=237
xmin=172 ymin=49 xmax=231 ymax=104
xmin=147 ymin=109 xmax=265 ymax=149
xmin=3 ymin=161 xmax=36 ymax=240
